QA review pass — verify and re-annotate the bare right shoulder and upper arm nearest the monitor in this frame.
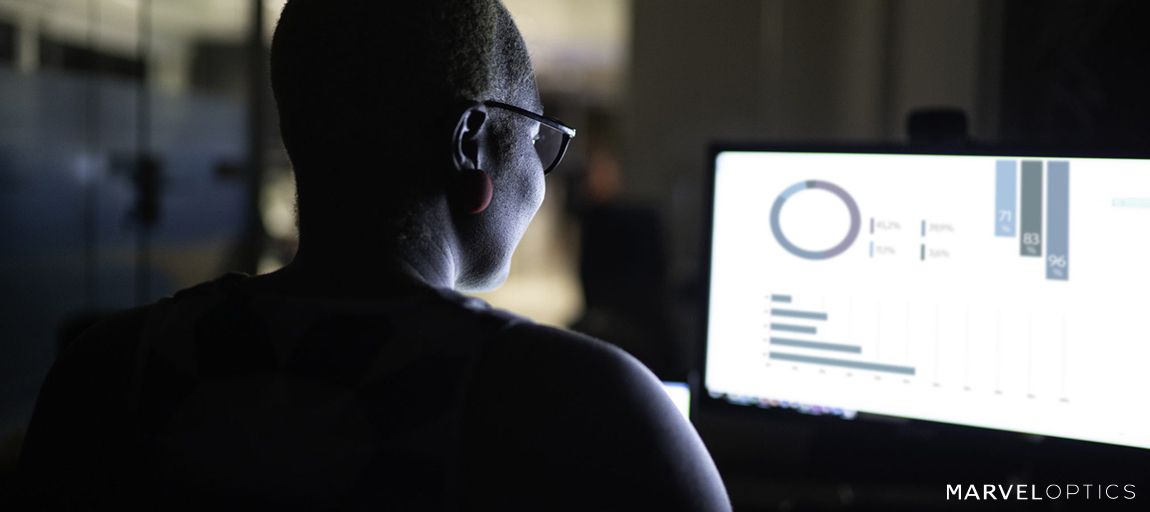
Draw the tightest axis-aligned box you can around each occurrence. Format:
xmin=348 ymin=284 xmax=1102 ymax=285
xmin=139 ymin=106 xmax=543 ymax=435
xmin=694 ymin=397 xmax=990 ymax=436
xmin=464 ymin=323 xmax=728 ymax=511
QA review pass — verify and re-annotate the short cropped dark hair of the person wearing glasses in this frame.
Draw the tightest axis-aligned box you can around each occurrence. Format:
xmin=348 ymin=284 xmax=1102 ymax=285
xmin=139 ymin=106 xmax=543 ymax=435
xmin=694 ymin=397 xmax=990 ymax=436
xmin=271 ymin=0 xmax=534 ymax=229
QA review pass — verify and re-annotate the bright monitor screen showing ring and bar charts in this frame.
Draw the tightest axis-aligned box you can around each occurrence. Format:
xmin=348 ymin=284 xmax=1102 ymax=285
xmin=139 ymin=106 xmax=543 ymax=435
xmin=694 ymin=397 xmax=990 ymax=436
xmin=703 ymin=146 xmax=1150 ymax=448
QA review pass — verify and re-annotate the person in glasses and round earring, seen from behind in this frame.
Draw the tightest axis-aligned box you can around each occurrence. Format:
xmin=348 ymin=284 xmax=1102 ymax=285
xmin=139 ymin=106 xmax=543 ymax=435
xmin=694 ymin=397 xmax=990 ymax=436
xmin=15 ymin=0 xmax=729 ymax=511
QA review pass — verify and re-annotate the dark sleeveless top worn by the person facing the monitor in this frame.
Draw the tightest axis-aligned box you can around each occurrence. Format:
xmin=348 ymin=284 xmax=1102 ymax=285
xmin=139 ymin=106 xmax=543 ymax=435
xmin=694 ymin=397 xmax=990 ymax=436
xmin=123 ymin=275 xmax=524 ymax=510
